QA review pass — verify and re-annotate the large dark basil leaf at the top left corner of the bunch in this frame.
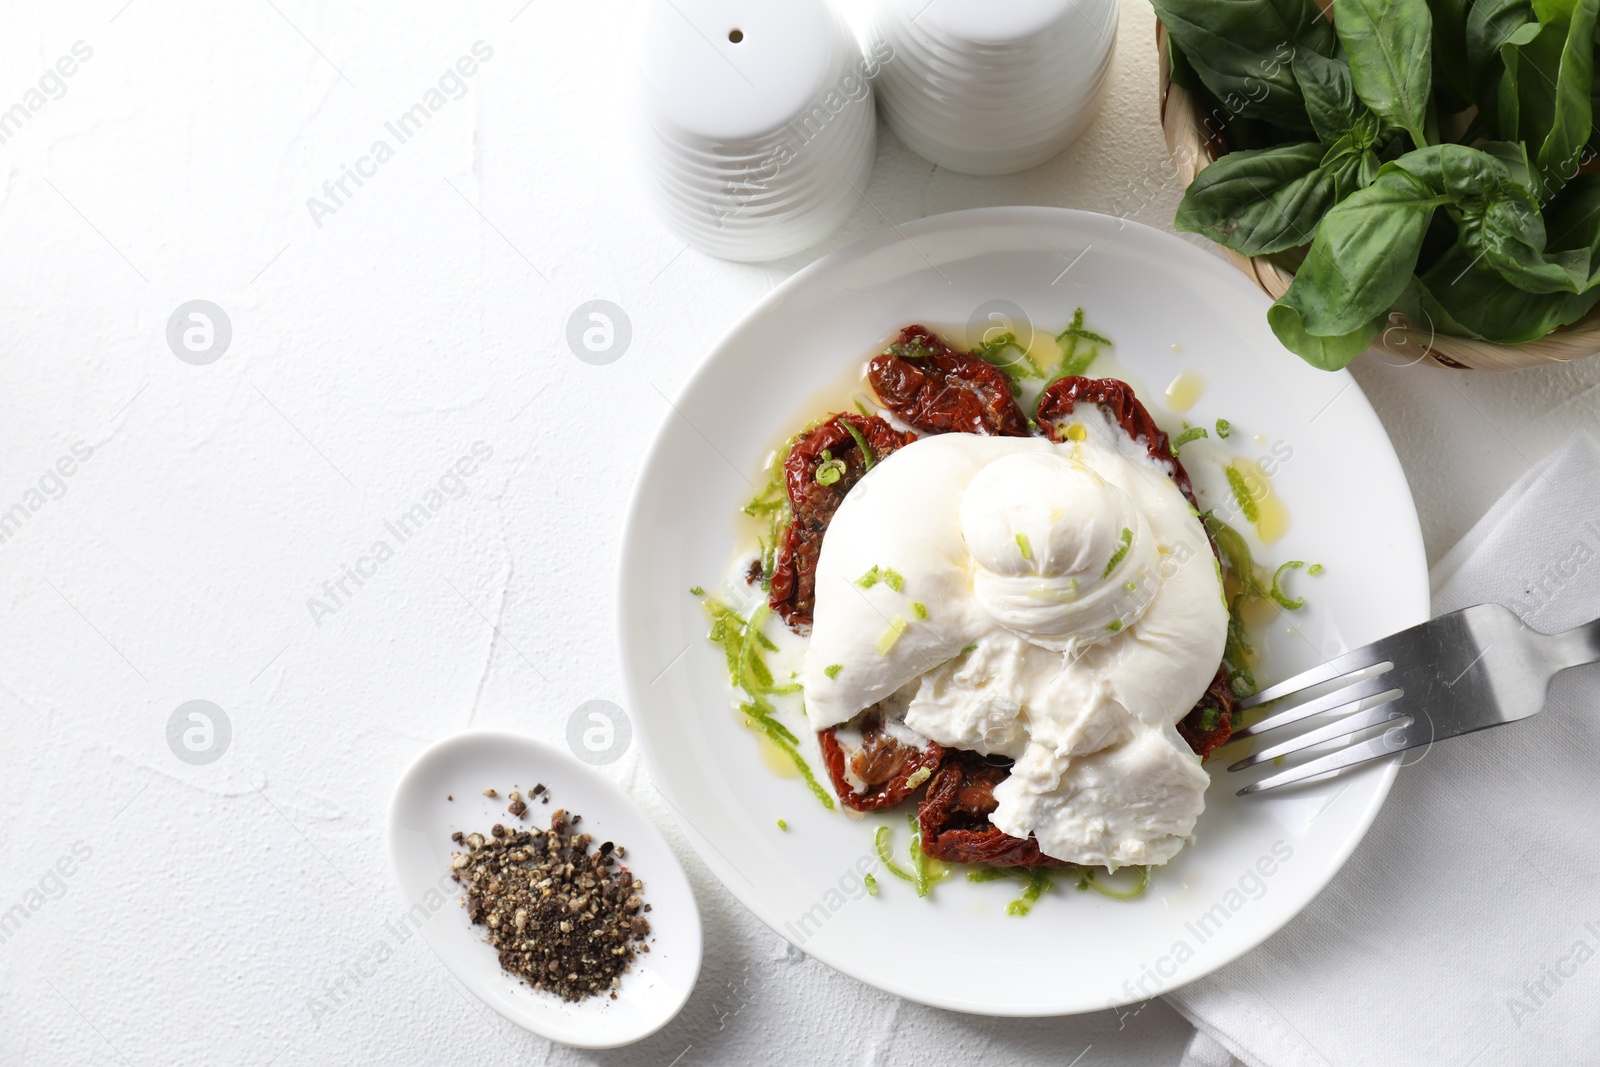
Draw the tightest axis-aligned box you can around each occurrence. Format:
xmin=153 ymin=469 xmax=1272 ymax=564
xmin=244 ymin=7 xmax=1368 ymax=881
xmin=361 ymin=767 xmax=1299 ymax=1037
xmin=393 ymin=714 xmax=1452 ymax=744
xmin=1152 ymin=0 xmax=1336 ymax=131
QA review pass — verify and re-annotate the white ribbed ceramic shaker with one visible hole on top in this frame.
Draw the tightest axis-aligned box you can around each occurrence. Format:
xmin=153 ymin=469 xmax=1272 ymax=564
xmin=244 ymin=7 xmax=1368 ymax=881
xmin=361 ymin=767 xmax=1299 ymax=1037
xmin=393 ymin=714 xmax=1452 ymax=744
xmin=634 ymin=0 xmax=877 ymax=261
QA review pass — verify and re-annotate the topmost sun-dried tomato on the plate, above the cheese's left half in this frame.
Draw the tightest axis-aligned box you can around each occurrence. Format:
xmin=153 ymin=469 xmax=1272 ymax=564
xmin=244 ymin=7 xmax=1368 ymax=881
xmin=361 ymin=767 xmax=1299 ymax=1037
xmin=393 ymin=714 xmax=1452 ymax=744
xmin=867 ymin=326 xmax=1029 ymax=437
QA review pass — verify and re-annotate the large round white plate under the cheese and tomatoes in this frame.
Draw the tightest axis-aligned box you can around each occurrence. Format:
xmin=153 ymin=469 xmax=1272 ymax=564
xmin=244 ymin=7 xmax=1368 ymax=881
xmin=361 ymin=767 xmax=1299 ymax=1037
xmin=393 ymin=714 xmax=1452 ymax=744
xmin=619 ymin=208 xmax=1429 ymax=1016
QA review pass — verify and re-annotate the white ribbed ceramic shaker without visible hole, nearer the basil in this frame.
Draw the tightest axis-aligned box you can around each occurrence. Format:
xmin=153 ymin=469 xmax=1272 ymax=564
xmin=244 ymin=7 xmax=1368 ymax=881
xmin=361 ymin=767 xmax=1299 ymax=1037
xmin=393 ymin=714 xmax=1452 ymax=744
xmin=867 ymin=0 xmax=1117 ymax=174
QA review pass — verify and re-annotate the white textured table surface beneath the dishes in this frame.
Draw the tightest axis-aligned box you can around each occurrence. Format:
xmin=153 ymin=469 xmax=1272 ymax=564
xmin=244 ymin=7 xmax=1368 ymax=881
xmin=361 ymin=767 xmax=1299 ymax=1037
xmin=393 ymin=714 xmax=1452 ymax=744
xmin=0 ymin=0 xmax=1600 ymax=1067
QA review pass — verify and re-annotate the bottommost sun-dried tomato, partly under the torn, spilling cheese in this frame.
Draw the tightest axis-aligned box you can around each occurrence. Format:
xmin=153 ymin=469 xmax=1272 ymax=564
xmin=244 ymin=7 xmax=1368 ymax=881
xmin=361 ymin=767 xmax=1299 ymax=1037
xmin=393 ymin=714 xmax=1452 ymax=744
xmin=917 ymin=749 xmax=1066 ymax=867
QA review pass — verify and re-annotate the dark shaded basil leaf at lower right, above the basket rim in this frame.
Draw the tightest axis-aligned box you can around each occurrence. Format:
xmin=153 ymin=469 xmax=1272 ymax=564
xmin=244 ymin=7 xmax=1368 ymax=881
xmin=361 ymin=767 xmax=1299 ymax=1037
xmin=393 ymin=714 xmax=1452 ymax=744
xmin=1419 ymin=245 xmax=1600 ymax=337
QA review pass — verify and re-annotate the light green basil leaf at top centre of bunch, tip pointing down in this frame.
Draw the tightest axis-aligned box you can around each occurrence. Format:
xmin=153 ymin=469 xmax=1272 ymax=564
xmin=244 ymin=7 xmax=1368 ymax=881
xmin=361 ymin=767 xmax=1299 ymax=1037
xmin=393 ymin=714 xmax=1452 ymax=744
xmin=1333 ymin=0 xmax=1434 ymax=147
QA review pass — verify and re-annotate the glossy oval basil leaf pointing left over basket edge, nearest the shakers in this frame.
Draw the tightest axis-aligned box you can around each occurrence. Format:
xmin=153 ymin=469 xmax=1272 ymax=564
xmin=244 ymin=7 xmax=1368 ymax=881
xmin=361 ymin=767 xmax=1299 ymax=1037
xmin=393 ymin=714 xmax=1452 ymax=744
xmin=1173 ymin=142 xmax=1334 ymax=256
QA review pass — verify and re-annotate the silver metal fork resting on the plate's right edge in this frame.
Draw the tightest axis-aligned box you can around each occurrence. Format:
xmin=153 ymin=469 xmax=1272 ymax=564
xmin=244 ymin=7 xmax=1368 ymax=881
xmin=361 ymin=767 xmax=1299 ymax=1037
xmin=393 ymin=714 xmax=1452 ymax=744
xmin=1227 ymin=605 xmax=1600 ymax=797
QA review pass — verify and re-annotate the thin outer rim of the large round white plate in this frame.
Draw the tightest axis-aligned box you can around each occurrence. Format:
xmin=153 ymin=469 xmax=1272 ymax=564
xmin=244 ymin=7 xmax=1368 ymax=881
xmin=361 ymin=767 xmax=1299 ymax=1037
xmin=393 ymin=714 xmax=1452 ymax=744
xmin=614 ymin=205 xmax=1432 ymax=1017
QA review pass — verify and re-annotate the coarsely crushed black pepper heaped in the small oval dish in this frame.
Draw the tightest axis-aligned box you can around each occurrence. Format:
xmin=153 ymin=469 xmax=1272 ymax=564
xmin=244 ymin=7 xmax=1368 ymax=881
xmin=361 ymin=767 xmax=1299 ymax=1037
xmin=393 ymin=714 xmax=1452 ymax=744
xmin=450 ymin=799 xmax=650 ymax=1001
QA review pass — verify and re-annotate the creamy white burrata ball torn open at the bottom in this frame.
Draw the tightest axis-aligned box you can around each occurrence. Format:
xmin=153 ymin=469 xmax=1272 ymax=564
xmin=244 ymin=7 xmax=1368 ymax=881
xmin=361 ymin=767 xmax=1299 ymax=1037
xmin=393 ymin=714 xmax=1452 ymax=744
xmin=802 ymin=408 xmax=1227 ymax=867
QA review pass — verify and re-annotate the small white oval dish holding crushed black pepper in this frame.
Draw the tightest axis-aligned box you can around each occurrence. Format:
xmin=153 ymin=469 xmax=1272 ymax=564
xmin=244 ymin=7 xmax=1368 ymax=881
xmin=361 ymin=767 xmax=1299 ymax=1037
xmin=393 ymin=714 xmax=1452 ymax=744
xmin=389 ymin=729 xmax=701 ymax=1048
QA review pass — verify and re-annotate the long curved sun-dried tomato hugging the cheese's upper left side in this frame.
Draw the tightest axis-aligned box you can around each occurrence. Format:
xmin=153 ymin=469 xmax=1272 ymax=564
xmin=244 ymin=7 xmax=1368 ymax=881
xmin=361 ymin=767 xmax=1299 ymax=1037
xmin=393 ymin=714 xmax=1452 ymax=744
xmin=768 ymin=414 xmax=917 ymax=630
